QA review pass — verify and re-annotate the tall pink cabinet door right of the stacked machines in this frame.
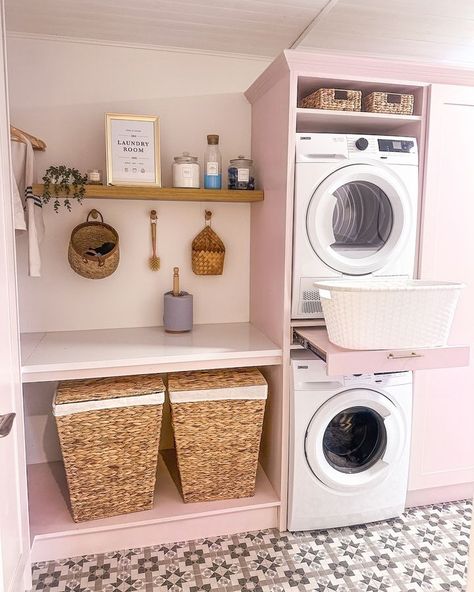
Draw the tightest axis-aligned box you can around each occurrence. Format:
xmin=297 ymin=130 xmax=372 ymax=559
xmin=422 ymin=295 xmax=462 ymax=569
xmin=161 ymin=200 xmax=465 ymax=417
xmin=409 ymin=85 xmax=474 ymax=495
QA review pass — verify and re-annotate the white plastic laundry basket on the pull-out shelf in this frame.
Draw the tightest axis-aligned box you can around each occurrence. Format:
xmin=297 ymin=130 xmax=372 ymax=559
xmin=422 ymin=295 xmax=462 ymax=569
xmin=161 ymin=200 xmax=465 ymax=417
xmin=315 ymin=278 xmax=464 ymax=349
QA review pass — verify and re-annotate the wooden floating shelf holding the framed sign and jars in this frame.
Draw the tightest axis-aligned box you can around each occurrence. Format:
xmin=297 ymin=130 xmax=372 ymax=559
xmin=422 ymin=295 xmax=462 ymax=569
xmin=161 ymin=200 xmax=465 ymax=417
xmin=33 ymin=185 xmax=263 ymax=203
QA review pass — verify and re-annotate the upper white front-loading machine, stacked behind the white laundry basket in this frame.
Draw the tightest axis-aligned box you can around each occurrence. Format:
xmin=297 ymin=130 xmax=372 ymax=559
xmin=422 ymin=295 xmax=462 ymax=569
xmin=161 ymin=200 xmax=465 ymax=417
xmin=292 ymin=133 xmax=418 ymax=319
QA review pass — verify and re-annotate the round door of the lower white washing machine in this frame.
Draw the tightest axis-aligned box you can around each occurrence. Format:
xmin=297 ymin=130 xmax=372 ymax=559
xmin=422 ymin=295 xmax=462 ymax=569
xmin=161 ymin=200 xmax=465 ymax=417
xmin=305 ymin=388 xmax=406 ymax=491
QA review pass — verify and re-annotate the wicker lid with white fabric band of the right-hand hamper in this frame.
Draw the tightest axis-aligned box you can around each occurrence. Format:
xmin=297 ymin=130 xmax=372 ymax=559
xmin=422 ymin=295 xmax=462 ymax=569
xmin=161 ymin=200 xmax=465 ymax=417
xmin=168 ymin=368 xmax=268 ymax=403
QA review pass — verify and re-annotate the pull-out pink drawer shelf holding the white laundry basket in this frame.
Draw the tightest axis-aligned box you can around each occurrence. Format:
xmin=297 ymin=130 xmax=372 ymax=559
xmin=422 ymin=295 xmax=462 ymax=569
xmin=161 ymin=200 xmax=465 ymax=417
xmin=295 ymin=327 xmax=469 ymax=376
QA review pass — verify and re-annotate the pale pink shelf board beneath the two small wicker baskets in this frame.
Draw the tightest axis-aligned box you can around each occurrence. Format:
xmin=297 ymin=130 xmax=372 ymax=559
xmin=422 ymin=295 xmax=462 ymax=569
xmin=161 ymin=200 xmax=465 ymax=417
xmin=296 ymin=108 xmax=422 ymax=134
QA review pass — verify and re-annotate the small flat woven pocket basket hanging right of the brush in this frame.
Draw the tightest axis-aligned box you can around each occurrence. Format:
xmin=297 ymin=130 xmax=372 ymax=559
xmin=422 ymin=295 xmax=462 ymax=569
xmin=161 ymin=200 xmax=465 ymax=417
xmin=192 ymin=210 xmax=225 ymax=275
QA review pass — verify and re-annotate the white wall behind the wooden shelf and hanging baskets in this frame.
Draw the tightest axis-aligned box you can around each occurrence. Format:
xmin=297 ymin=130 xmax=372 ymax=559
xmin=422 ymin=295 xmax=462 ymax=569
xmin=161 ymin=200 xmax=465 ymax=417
xmin=8 ymin=37 xmax=268 ymax=331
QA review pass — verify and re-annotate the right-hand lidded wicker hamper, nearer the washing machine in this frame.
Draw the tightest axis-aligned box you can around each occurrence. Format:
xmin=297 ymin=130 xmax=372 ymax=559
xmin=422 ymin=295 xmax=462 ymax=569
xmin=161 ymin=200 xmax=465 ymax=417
xmin=168 ymin=368 xmax=268 ymax=502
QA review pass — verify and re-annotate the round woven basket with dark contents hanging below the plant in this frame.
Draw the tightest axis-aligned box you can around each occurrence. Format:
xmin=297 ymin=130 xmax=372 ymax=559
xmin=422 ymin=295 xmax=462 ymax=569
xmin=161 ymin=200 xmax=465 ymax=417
xmin=68 ymin=210 xmax=120 ymax=280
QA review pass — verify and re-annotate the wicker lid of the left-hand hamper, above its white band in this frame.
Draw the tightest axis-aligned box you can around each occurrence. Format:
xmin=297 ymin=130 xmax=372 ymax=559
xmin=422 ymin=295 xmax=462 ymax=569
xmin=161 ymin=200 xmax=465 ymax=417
xmin=55 ymin=374 xmax=165 ymax=405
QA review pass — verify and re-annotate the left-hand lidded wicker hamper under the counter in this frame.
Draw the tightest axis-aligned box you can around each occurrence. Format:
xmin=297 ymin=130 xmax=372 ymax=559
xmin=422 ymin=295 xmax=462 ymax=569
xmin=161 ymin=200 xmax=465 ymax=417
xmin=53 ymin=375 xmax=164 ymax=522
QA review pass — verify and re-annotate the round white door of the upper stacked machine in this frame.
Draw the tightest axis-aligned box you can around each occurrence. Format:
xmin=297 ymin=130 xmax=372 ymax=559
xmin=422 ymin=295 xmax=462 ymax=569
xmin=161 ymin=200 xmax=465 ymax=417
xmin=306 ymin=163 xmax=415 ymax=275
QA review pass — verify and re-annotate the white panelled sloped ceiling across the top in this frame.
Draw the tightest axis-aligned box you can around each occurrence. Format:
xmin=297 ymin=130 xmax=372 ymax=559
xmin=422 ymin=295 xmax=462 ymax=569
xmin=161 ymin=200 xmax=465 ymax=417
xmin=6 ymin=0 xmax=474 ymax=66
